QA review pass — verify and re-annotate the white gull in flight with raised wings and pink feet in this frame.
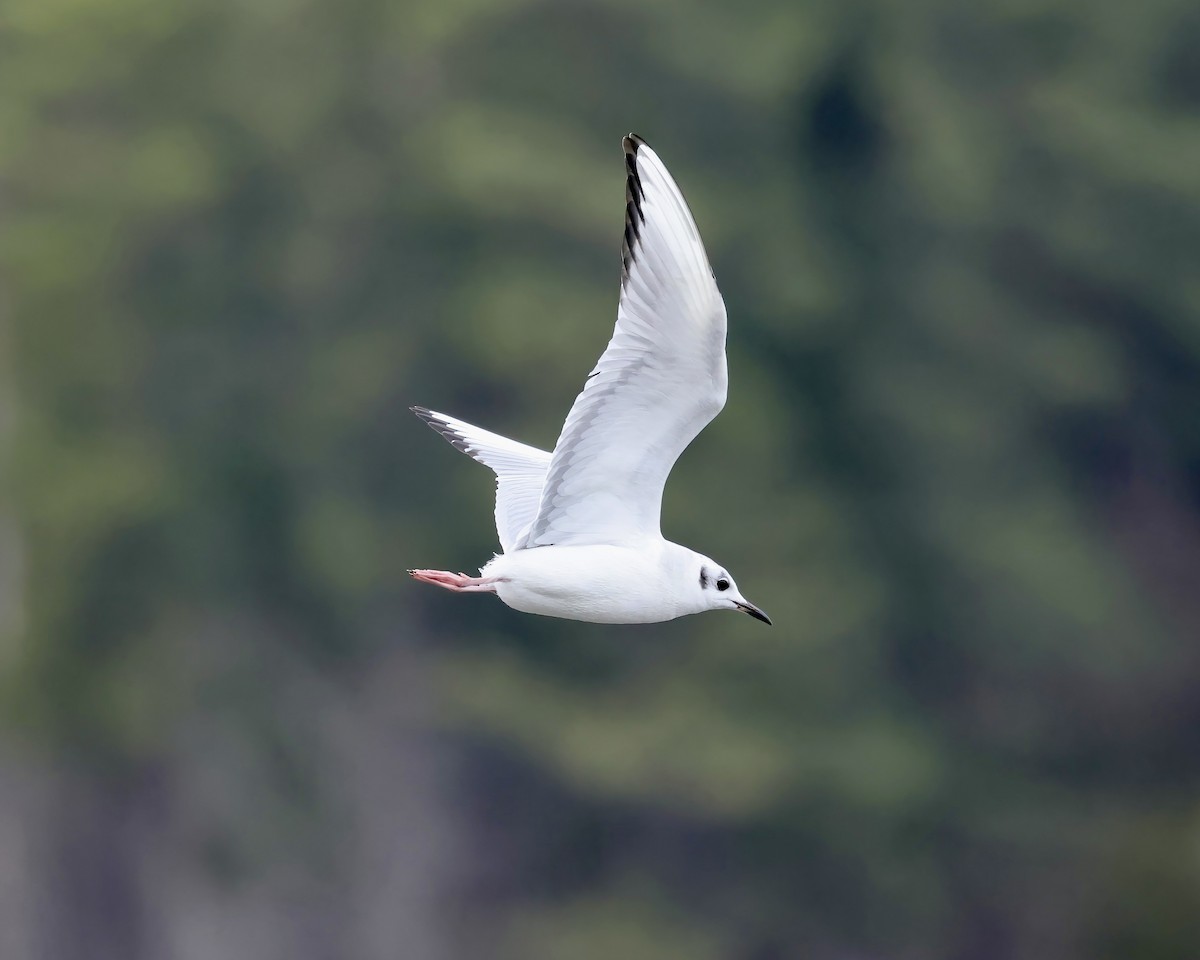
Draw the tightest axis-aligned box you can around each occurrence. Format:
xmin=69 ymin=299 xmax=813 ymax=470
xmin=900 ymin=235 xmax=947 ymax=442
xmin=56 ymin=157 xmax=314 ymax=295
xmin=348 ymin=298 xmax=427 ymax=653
xmin=409 ymin=133 xmax=770 ymax=624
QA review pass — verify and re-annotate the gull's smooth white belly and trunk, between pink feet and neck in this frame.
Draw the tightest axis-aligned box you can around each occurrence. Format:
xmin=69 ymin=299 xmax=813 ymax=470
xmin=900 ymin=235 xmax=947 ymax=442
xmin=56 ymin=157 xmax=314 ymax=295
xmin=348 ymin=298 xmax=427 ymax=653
xmin=482 ymin=545 xmax=683 ymax=623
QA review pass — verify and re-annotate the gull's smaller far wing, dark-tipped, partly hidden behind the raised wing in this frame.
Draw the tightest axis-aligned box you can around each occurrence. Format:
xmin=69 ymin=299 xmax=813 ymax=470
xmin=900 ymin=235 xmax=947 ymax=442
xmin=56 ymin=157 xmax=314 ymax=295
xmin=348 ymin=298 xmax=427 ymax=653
xmin=412 ymin=407 xmax=550 ymax=553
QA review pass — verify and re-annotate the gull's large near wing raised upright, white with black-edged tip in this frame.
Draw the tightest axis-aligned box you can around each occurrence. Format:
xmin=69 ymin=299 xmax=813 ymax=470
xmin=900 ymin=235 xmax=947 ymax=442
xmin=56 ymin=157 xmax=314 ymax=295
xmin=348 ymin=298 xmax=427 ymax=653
xmin=517 ymin=134 xmax=727 ymax=547
